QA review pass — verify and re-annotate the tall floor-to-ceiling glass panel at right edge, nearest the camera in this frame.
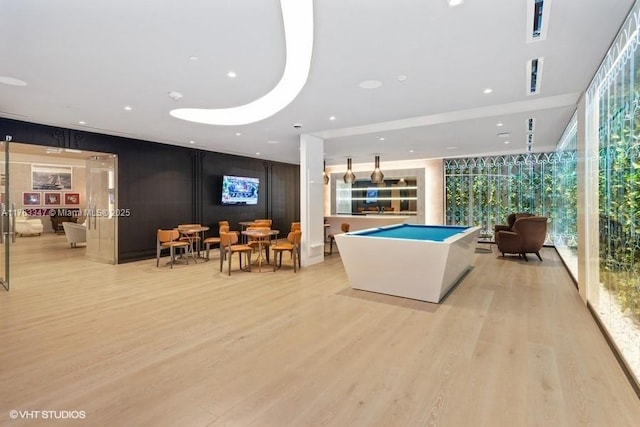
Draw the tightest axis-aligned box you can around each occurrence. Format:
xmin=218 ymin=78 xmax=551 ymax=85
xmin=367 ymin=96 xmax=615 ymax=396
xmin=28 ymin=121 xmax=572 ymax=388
xmin=585 ymin=4 xmax=640 ymax=381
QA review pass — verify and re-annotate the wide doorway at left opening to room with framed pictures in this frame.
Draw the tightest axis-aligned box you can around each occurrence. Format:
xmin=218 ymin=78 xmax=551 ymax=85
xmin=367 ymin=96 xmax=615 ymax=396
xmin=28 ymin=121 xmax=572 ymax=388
xmin=0 ymin=141 xmax=118 ymax=290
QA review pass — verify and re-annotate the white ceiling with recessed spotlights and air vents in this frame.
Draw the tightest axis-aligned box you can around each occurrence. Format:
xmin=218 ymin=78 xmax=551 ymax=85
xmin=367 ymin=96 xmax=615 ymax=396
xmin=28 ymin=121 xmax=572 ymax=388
xmin=0 ymin=0 xmax=633 ymax=165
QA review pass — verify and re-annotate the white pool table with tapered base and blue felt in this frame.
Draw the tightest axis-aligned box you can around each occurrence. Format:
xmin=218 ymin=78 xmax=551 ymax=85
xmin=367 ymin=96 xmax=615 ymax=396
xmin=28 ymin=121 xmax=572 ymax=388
xmin=335 ymin=224 xmax=481 ymax=303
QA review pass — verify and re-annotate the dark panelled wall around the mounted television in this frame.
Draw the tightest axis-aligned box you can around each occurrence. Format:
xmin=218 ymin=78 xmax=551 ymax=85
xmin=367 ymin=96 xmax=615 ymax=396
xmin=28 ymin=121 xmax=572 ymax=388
xmin=0 ymin=118 xmax=300 ymax=262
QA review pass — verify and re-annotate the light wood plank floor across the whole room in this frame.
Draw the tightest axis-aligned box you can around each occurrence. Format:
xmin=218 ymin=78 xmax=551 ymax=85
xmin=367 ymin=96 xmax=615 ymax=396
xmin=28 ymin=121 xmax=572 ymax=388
xmin=0 ymin=235 xmax=640 ymax=427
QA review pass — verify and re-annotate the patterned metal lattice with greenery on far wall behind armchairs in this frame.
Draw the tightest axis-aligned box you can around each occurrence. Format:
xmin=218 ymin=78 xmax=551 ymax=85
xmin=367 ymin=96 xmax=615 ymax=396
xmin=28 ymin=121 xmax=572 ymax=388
xmin=444 ymin=150 xmax=577 ymax=247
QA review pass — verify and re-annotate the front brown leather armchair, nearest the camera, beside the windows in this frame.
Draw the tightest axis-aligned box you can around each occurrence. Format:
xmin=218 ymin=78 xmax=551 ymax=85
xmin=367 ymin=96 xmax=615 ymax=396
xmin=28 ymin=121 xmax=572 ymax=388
xmin=495 ymin=216 xmax=547 ymax=261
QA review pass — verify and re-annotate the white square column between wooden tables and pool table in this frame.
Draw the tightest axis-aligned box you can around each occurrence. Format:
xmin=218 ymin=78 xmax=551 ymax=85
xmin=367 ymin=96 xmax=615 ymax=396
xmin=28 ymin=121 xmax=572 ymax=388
xmin=300 ymin=134 xmax=324 ymax=265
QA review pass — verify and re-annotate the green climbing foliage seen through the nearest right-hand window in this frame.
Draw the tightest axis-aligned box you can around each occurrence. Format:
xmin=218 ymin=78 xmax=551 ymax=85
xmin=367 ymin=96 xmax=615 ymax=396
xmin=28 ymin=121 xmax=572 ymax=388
xmin=598 ymin=51 xmax=640 ymax=323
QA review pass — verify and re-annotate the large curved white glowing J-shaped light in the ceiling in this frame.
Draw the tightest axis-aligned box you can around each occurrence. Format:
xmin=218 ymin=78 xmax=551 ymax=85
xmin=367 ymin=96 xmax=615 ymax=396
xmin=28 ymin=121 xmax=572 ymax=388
xmin=169 ymin=0 xmax=314 ymax=126
